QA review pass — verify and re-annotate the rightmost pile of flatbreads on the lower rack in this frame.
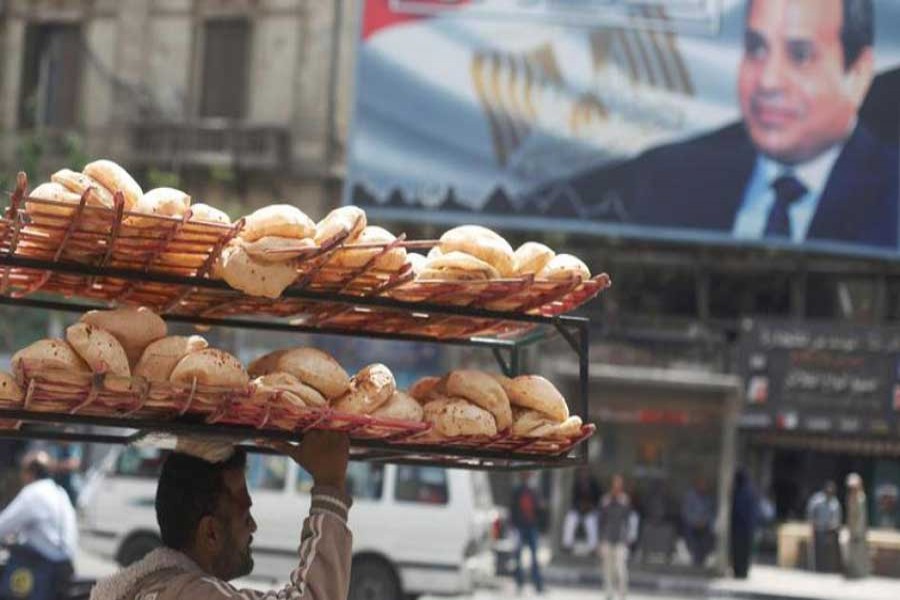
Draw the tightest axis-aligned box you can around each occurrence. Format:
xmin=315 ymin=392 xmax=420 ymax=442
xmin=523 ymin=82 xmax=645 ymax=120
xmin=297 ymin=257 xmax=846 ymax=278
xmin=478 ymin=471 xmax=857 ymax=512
xmin=409 ymin=369 xmax=582 ymax=438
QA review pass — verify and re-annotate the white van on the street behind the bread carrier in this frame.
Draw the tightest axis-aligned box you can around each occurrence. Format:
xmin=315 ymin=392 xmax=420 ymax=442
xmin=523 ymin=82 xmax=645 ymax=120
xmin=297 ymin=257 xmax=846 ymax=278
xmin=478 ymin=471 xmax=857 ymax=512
xmin=78 ymin=446 xmax=499 ymax=600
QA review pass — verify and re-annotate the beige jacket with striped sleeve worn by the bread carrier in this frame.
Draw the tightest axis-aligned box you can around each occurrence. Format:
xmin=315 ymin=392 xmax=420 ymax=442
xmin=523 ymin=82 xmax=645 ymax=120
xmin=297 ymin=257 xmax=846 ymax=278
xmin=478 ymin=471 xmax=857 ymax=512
xmin=91 ymin=488 xmax=352 ymax=600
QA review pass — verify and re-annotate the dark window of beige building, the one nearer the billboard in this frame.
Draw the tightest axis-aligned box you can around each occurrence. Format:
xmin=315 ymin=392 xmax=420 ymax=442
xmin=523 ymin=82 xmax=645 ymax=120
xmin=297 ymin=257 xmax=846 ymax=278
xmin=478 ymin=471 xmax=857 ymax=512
xmin=199 ymin=19 xmax=250 ymax=119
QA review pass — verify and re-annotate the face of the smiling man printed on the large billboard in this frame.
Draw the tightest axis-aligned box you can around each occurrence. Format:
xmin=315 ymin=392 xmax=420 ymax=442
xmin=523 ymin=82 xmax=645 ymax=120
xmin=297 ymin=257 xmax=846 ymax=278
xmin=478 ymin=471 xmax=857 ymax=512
xmin=738 ymin=0 xmax=872 ymax=164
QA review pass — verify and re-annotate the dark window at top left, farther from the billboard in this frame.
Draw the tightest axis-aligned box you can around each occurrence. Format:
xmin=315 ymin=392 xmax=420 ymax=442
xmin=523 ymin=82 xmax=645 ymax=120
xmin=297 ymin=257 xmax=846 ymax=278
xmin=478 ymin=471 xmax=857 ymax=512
xmin=19 ymin=25 xmax=82 ymax=129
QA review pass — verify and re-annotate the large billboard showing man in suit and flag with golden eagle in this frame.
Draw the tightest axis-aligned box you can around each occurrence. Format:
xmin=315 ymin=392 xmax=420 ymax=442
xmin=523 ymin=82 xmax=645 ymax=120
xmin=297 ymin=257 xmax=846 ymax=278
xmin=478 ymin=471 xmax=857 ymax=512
xmin=345 ymin=0 xmax=900 ymax=257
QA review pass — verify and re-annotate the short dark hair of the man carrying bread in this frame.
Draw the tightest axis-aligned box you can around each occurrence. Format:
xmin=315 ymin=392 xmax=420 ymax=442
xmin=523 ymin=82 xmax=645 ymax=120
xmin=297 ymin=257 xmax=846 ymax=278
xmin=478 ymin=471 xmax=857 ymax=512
xmin=156 ymin=448 xmax=247 ymax=550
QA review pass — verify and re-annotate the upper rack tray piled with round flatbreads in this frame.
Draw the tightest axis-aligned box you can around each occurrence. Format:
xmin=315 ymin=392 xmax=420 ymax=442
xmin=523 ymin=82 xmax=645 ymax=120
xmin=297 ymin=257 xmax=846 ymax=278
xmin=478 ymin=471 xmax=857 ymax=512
xmin=0 ymin=160 xmax=610 ymax=338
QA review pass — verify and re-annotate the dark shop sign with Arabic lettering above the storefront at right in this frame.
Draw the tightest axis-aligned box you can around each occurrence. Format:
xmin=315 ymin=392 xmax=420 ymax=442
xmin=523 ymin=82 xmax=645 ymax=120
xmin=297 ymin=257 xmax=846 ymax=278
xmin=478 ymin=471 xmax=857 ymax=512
xmin=738 ymin=320 xmax=900 ymax=437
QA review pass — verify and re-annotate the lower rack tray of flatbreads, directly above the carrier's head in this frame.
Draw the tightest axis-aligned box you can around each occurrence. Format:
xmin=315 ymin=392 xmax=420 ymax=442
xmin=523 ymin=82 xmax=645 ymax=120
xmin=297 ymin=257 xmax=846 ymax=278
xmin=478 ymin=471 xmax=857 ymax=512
xmin=0 ymin=307 xmax=594 ymax=458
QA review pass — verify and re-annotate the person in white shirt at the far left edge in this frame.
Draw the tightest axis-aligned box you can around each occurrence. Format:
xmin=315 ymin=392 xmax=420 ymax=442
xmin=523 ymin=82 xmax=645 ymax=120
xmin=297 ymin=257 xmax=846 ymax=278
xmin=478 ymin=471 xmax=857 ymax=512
xmin=0 ymin=451 xmax=78 ymax=600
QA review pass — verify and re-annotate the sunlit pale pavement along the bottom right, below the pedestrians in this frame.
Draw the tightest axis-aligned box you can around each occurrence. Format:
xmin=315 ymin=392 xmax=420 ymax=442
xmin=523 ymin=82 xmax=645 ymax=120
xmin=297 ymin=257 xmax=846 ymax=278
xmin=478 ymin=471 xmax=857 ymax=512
xmin=544 ymin=561 xmax=900 ymax=600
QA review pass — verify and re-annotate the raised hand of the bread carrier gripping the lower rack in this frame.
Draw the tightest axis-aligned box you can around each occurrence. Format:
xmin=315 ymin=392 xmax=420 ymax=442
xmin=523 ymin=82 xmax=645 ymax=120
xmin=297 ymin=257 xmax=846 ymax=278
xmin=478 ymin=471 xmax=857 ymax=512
xmin=272 ymin=429 xmax=350 ymax=491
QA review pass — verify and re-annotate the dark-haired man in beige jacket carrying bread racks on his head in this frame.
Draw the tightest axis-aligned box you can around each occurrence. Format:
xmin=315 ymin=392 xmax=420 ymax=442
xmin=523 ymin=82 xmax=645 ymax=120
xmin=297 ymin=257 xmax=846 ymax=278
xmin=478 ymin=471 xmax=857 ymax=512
xmin=91 ymin=431 xmax=352 ymax=600
